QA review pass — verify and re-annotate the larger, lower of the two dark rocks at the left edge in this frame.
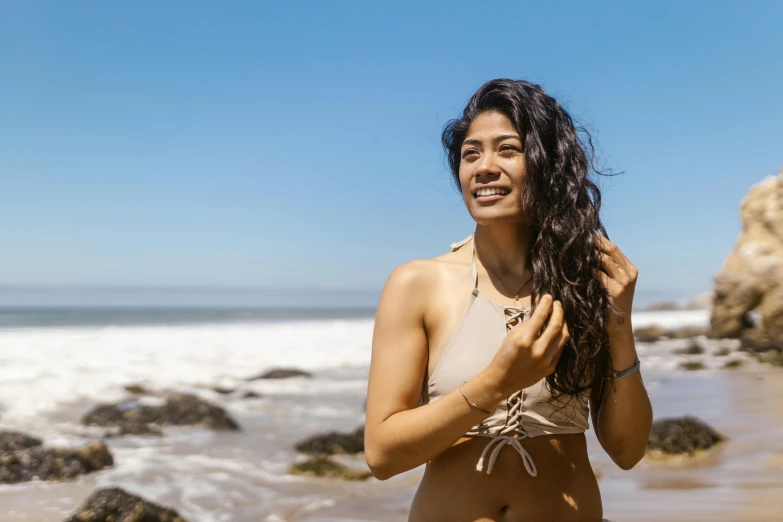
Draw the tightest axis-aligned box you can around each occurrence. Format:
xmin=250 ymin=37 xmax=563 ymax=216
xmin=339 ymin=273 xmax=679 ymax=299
xmin=0 ymin=442 xmax=114 ymax=484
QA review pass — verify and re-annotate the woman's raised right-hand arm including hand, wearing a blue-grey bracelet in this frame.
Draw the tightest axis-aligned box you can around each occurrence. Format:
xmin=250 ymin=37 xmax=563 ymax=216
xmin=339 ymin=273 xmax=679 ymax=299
xmin=590 ymin=234 xmax=652 ymax=469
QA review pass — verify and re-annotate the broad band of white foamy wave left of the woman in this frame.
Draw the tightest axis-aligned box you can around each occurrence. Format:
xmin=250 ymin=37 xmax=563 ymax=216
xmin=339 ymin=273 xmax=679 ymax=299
xmin=0 ymin=319 xmax=373 ymax=425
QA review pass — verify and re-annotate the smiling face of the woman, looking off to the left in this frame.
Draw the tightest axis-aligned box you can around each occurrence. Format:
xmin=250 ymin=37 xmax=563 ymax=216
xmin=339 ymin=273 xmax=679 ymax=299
xmin=459 ymin=111 xmax=527 ymax=224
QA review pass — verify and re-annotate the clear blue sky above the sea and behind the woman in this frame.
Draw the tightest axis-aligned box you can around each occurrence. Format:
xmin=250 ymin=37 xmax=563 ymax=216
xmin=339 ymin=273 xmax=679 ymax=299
xmin=0 ymin=1 xmax=783 ymax=300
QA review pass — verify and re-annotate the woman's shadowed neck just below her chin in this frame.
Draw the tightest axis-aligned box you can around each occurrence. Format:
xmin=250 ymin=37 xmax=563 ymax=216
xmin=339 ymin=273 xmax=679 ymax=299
xmin=473 ymin=223 xmax=532 ymax=280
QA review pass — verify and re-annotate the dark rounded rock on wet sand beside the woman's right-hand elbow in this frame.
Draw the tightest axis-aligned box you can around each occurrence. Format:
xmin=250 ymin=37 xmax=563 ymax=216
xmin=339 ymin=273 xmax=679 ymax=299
xmin=647 ymin=416 xmax=726 ymax=456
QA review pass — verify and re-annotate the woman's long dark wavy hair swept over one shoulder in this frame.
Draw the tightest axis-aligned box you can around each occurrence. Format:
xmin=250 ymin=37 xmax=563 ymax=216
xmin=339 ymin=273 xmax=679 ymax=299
xmin=442 ymin=79 xmax=619 ymax=401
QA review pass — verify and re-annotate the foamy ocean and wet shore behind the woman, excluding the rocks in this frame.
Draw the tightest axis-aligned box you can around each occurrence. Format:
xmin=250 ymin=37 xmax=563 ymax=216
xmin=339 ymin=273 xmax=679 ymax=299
xmin=0 ymin=307 xmax=783 ymax=522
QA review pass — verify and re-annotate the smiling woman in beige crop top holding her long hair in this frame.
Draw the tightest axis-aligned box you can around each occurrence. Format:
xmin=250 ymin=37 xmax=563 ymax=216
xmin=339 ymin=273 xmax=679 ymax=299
xmin=365 ymin=79 xmax=652 ymax=522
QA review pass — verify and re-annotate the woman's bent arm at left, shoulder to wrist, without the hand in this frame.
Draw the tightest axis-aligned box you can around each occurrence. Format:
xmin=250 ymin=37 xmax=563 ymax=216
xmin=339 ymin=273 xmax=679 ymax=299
xmin=364 ymin=261 xmax=504 ymax=480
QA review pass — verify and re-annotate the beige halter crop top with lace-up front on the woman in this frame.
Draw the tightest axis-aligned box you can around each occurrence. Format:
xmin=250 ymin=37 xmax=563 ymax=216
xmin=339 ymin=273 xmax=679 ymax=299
xmin=422 ymin=234 xmax=589 ymax=477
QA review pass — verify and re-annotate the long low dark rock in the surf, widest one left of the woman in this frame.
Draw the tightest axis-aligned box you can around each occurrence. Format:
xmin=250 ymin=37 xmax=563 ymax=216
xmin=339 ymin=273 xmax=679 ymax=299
xmin=82 ymin=393 xmax=239 ymax=434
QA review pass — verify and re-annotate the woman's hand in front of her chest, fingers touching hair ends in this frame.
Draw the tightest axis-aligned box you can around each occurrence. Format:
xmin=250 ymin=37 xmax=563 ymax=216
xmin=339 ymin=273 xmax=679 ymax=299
xmin=487 ymin=294 xmax=571 ymax=396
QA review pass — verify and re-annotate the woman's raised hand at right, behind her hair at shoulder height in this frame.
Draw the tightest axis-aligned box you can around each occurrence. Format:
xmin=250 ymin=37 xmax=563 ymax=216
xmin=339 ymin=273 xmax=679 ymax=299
xmin=595 ymin=233 xmax=639 ymax=328
